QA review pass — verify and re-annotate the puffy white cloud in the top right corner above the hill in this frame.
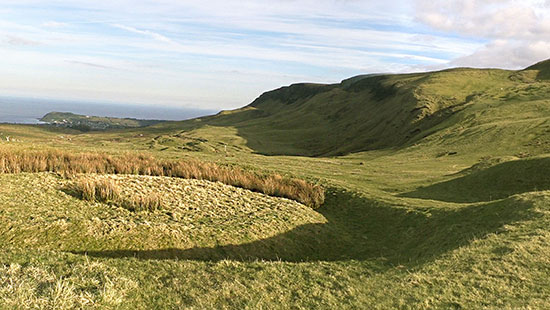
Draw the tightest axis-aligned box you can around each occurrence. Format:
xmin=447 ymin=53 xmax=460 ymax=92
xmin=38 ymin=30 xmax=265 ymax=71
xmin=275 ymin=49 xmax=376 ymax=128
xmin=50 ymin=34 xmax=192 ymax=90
xmin=416 ymin=0 xmax=550 ymax=69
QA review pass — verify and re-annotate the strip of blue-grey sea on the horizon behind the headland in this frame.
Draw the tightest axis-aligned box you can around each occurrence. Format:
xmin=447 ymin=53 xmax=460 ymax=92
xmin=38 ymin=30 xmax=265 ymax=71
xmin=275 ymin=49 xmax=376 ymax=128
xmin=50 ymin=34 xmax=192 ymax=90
xmin=0 ymin=96 xmax=218 ymax=124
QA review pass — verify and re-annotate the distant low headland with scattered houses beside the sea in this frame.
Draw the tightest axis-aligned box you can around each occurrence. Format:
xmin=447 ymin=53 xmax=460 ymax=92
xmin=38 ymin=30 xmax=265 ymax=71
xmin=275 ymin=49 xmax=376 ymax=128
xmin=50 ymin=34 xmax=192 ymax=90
xmin=40 ymin=112 xmax=162 ymax=131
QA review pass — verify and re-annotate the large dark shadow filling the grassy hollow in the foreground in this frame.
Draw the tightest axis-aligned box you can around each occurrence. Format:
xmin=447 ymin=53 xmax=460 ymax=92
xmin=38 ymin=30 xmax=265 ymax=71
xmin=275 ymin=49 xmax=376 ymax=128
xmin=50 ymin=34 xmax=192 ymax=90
xmin=76 ymin=191 xmax=534 ymax=266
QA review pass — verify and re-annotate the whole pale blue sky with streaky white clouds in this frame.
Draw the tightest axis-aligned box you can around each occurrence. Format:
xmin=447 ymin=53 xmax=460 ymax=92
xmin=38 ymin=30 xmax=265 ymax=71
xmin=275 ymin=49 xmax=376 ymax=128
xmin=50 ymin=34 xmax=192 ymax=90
xmin=0 ymin=0 xmax=550 ymax=109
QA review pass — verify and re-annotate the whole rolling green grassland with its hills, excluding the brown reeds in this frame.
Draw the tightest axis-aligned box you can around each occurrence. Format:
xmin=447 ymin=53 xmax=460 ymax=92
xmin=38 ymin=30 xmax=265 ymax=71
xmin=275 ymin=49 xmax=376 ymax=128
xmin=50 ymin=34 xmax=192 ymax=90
xmin=0 ymin=61 xmax=550 ymax=309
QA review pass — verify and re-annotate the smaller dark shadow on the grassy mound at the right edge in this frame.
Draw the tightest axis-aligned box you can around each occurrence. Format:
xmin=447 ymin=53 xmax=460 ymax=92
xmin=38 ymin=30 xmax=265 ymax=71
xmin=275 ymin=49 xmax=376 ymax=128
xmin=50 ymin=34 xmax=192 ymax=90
xmin=400 ymin=158 xmax=550 ymax=203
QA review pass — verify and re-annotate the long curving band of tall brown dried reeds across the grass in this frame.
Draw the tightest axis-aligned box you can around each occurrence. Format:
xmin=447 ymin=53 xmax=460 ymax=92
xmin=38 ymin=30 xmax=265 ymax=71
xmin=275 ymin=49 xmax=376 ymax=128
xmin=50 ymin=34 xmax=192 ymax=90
xmin=0 ymin=150 xmax=325 ymax=207
